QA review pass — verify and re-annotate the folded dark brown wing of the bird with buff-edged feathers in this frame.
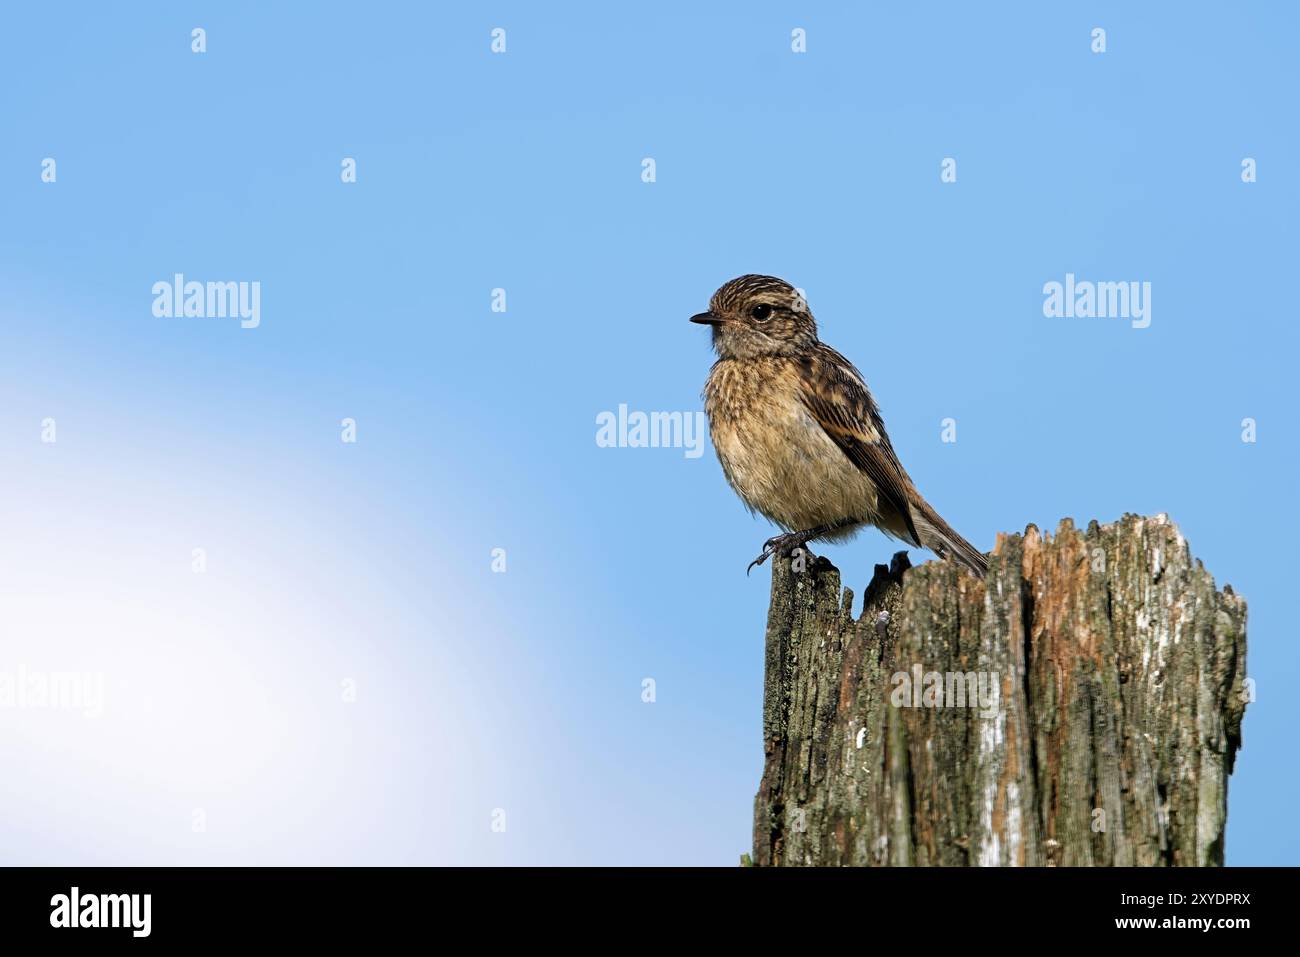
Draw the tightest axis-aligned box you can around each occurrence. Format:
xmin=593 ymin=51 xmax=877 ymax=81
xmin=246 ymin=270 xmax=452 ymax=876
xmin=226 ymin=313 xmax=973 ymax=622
xmin=800 ymin=343 xmax=920 ymax=545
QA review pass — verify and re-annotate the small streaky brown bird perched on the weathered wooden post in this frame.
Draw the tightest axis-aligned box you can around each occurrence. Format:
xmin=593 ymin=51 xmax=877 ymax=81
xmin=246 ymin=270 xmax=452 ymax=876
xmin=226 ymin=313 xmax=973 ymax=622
xmin=690 ymin=274 xmax=988 ymax=577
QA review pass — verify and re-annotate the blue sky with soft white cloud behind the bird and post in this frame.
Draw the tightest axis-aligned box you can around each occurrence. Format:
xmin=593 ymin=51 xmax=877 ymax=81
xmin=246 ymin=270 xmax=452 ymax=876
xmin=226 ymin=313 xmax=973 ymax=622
xmin=0 ymin=3 xmax=1300 ymax=865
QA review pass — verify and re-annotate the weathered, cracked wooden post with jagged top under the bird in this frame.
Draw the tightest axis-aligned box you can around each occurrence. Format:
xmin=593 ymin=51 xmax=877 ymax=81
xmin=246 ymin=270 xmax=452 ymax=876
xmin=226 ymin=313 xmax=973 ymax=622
xmin=753 ymin=515 xmax=1248 ymax=866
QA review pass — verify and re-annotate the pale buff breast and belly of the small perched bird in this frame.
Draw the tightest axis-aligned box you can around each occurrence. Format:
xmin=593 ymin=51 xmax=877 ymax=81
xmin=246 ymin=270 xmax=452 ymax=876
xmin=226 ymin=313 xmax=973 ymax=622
xmin=705 ymin=359 xmax=878 ymax=537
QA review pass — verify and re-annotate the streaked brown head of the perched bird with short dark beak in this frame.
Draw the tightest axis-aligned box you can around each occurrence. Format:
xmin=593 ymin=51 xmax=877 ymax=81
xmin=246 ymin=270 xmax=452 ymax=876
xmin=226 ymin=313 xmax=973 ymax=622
xmin=690 ymin=276 xmax=816 ymax=359
